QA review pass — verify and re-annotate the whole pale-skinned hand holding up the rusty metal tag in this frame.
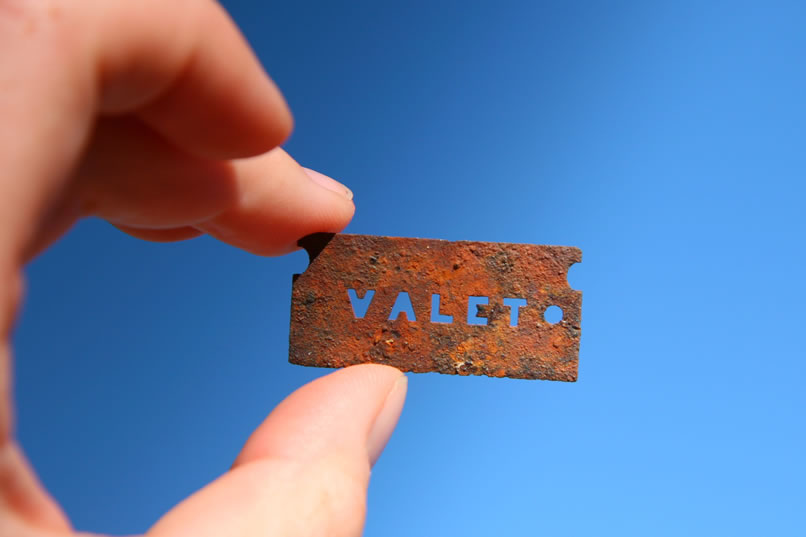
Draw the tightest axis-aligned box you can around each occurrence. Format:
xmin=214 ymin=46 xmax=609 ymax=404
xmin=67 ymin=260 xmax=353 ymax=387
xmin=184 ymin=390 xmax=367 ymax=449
xmin=0 ymin=0 xmax=406 ymax=537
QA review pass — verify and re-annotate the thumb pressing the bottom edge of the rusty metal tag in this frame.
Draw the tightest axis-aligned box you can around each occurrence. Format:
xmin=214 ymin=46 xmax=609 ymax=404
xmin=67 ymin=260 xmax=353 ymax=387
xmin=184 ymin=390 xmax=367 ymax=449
xmin=149 ymin=365 xmax=407 ymax=537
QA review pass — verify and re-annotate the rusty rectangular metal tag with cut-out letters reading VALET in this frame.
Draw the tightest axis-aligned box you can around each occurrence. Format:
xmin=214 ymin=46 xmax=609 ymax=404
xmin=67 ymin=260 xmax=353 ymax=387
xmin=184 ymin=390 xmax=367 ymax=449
xmin=289 ymin=233 xmax=582 ymax=381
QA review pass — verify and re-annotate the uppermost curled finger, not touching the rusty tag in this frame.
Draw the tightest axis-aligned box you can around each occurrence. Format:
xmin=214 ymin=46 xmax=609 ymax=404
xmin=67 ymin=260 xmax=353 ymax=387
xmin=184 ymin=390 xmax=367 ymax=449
xmin=92 ymin=0 xmax=292 ymax=159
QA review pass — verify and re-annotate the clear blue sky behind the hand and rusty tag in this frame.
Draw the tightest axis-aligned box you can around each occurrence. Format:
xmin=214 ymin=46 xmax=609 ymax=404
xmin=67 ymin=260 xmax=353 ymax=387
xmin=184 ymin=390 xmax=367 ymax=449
xmin=16 ymin=1 xmax=806 ymax=537
